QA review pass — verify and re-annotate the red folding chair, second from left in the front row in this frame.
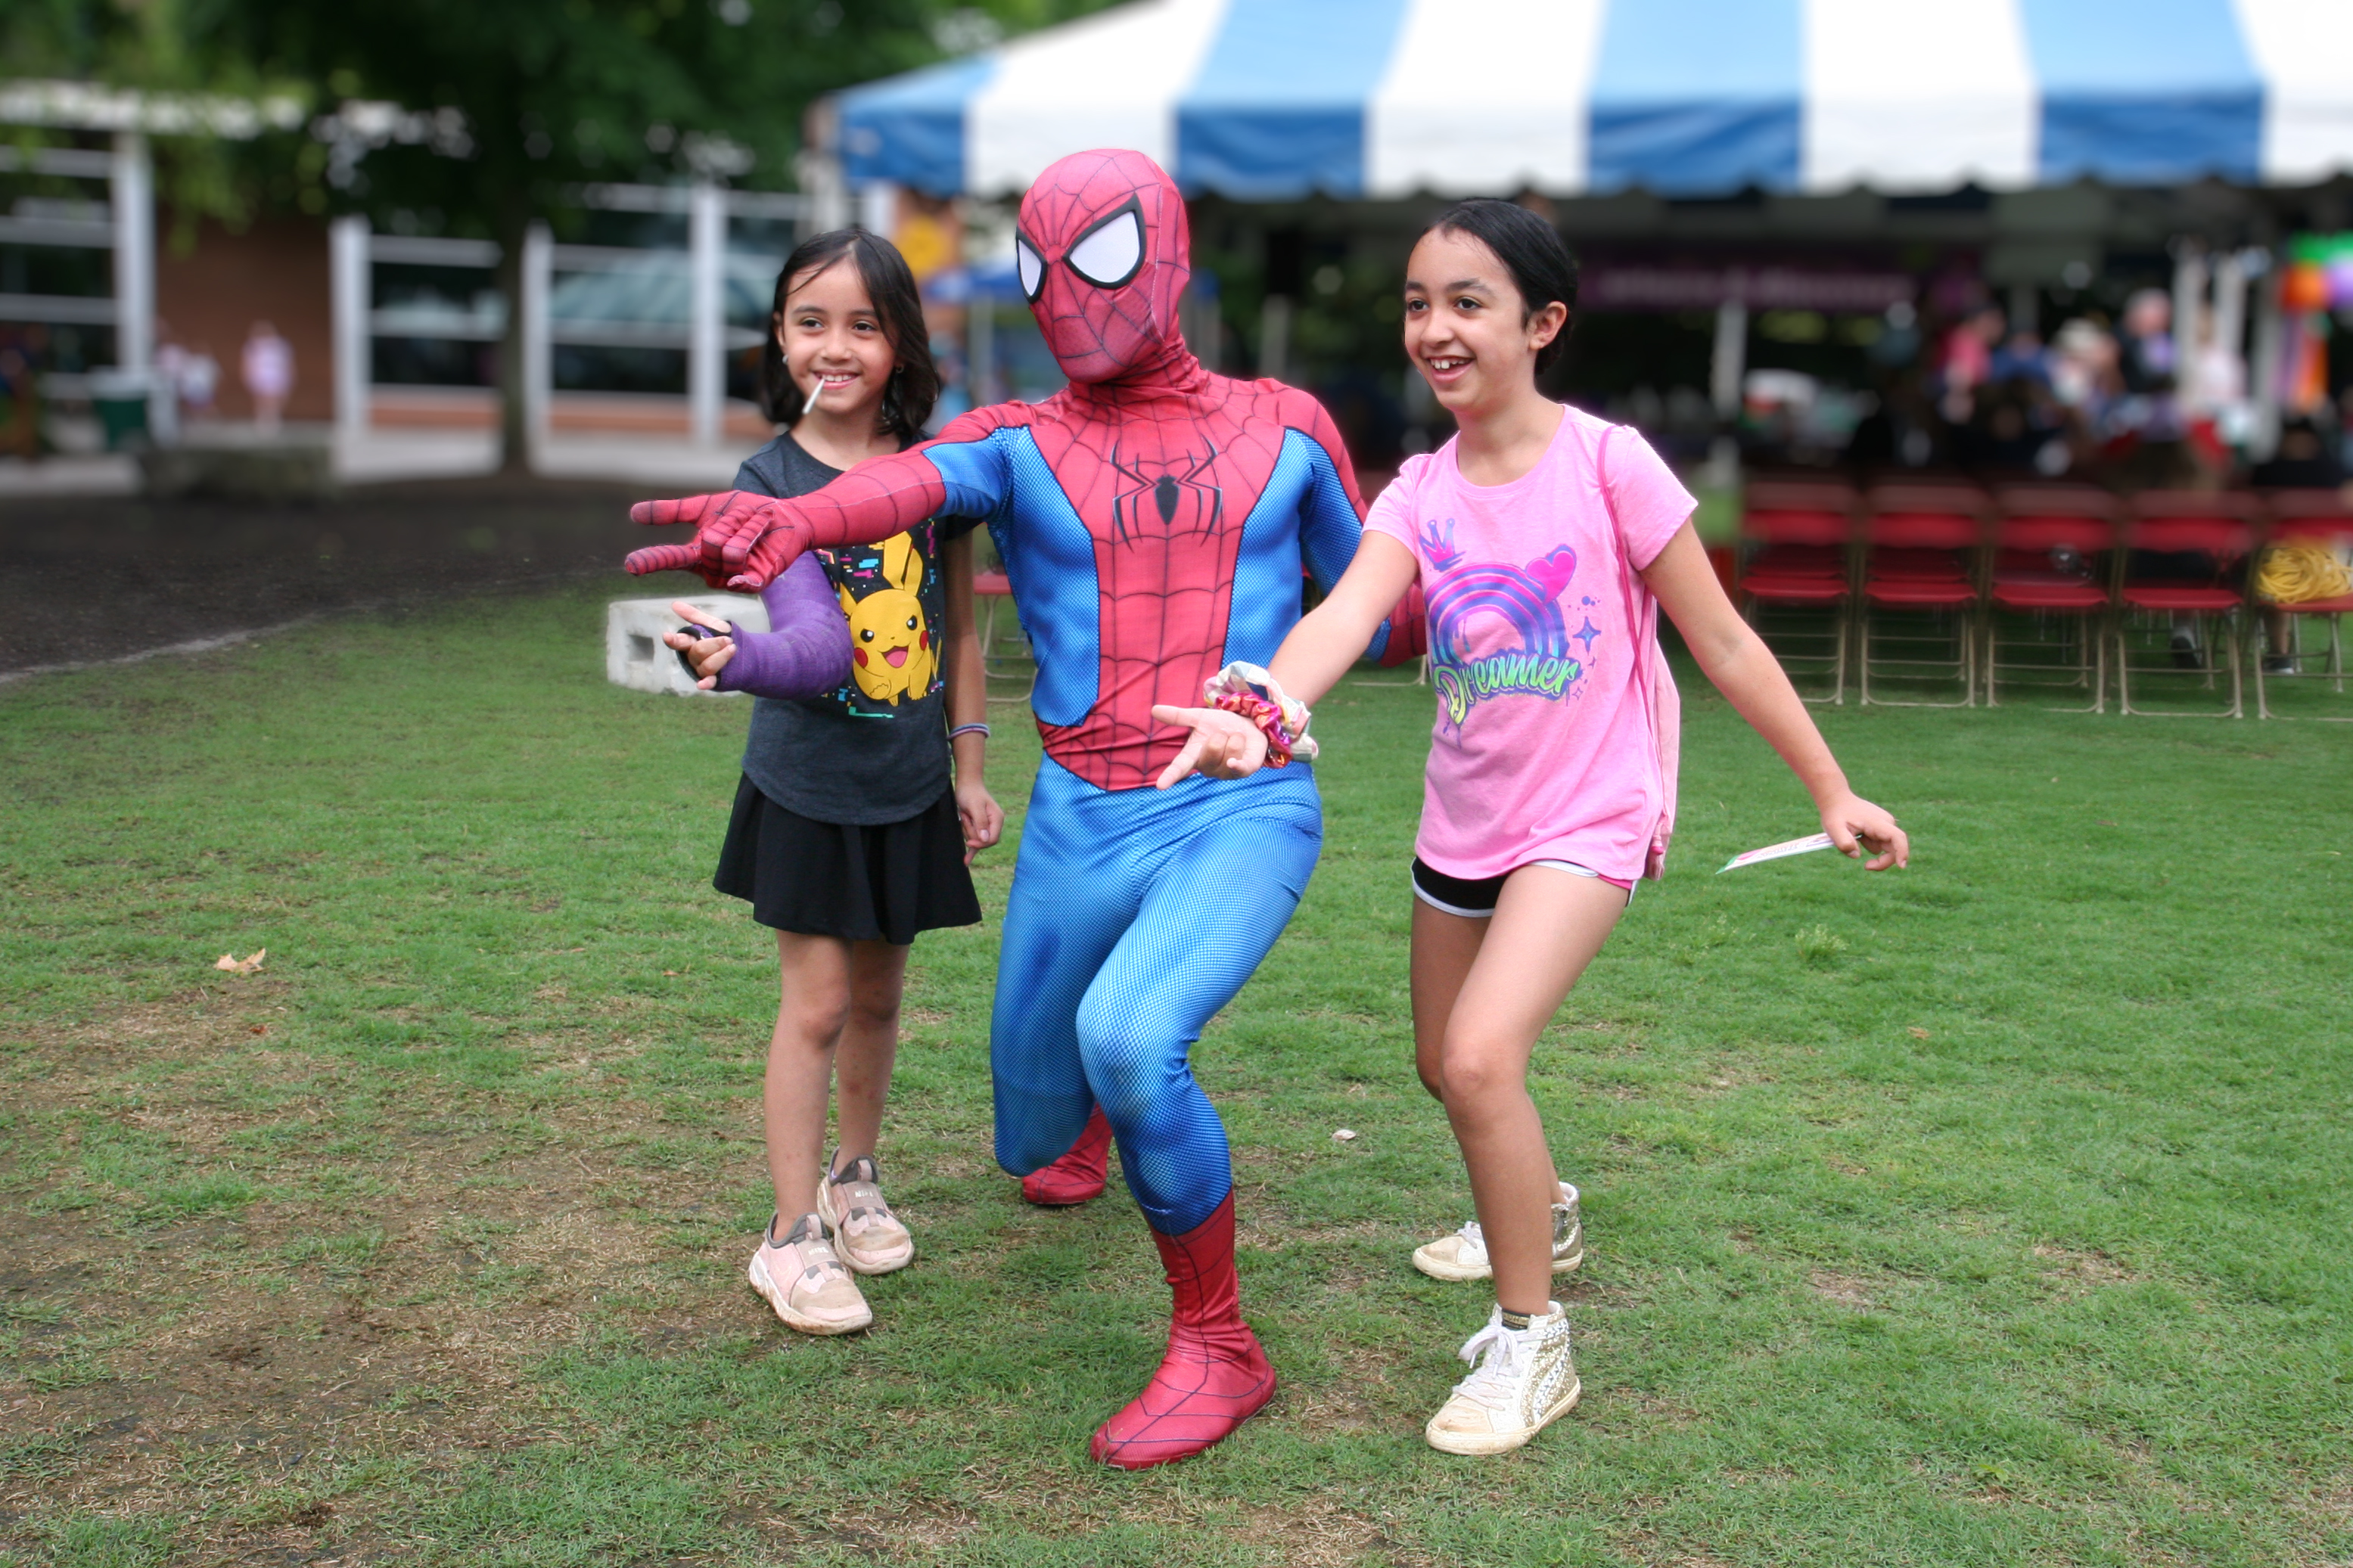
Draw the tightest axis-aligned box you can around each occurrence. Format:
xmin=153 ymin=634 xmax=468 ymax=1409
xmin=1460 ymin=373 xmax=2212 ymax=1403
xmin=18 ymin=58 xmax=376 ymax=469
xmin=1857 ymin=484 xmax=1986 ymax=707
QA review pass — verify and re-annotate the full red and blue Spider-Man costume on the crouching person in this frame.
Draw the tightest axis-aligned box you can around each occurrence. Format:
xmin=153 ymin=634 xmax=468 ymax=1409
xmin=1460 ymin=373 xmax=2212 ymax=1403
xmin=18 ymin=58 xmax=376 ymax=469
xmin=628 ymin=151 xmax=1421 ymax=1469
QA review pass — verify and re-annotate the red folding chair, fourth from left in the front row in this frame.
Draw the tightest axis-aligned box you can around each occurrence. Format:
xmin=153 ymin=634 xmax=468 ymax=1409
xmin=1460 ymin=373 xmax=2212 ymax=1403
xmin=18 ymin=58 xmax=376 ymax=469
xmin=2115 ymin=492 xmax=2256 ymax=719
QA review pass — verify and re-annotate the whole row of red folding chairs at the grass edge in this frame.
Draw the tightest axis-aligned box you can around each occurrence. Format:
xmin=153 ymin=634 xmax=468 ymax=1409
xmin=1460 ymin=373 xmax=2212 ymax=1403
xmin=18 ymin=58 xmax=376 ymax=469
xmin=1732 ymin=480 xmax=2353 ymax=717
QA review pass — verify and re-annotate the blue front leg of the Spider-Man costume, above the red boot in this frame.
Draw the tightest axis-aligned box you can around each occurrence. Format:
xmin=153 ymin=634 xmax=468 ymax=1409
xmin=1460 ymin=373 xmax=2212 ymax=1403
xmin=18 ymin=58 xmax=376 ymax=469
xmin=1077 ymin=768 xmax=1323 ymax=1237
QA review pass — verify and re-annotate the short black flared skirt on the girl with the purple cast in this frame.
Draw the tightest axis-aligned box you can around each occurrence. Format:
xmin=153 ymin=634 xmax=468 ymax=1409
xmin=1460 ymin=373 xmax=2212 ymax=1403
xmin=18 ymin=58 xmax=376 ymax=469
xmin=710 ymin=778 xmax=981 ymax=948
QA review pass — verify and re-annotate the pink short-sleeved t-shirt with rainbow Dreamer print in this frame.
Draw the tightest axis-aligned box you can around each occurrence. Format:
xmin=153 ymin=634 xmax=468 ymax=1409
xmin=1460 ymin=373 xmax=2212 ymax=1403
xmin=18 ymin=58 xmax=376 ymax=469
xmin=1365 ymin=409 xmax=1696 ymax=877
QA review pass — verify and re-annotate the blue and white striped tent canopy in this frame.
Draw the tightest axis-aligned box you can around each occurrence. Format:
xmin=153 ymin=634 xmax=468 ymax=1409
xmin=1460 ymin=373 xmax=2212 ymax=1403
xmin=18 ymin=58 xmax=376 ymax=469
xmin=838 ymin=0 xmax=2353 ymax=200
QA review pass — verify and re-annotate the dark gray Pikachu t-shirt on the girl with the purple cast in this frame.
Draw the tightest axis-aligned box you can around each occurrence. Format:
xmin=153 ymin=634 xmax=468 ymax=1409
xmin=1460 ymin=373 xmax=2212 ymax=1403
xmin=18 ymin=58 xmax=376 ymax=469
xmin=736 ymin=435 xmax=971 ymax=827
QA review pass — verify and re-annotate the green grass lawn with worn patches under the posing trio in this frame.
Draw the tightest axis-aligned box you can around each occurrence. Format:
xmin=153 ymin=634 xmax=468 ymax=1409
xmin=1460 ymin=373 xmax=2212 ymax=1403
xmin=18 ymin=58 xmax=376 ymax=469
xmin=0 ymin=592 xmax=2353 ymax=1568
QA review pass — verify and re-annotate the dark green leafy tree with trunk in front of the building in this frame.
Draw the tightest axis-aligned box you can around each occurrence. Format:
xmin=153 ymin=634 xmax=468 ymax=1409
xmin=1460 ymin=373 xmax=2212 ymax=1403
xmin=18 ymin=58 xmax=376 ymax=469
xmin=0 ymin=0 xmax=1101 ymax=461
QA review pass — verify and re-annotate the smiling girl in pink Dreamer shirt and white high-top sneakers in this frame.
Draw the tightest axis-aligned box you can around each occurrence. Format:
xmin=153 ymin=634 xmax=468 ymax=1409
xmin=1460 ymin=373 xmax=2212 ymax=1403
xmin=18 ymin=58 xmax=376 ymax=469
xmin=1153 ymin=200 xmax=1910 ymax=1453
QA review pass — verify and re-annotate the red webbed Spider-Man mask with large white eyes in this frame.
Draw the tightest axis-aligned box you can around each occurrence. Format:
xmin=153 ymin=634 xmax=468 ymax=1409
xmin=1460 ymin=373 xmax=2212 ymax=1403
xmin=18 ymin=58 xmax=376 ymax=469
xmin=1014 ymin=151 xmax=1193 ymax=380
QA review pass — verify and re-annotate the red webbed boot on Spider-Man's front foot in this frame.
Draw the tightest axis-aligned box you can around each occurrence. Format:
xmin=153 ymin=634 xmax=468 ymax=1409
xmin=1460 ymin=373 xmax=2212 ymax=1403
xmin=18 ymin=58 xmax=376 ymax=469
xmin=1089 ymin=1192 xmax=1276 ymax=1469
